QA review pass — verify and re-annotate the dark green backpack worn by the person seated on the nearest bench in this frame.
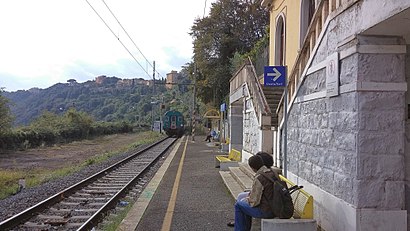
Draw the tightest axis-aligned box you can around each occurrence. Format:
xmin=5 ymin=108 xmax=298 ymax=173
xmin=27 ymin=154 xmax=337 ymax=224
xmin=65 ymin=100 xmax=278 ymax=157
xmin=261 ymin=173 xmax=303 ymax=219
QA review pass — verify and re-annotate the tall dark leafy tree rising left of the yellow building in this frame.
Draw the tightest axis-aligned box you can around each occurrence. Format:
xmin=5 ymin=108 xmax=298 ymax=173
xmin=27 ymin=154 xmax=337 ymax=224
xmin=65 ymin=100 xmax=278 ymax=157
xmin=190 ymin=0 xmax=269 ymax=106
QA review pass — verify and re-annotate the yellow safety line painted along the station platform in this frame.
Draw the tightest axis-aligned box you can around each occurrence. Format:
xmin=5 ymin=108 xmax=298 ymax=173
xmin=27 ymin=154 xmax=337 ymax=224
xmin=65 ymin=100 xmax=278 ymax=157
xmin=161 ymin=138 xmax=188 ymax=231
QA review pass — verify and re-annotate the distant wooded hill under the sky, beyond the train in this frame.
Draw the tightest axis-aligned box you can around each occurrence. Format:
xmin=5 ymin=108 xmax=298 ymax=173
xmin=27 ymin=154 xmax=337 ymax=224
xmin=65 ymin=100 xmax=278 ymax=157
xmin=3 ymin=76 xmax=192 ymax=126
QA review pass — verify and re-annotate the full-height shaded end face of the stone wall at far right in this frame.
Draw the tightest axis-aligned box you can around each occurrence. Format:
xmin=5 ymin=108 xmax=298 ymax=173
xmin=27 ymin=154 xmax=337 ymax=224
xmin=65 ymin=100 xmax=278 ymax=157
xmin=353 ymin=36 xmax=406 ymax=230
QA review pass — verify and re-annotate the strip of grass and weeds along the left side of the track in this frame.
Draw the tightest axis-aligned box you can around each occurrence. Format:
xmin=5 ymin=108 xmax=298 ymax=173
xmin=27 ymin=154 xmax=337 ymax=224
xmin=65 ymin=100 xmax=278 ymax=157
xmin=0 ymin=131 xmax=165 ymax=200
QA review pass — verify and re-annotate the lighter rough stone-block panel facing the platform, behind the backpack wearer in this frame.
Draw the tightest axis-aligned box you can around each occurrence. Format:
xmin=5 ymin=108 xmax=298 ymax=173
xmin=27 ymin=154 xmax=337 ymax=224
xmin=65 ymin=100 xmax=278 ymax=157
xmin=288 ymin=83 xmax=358 ymax=204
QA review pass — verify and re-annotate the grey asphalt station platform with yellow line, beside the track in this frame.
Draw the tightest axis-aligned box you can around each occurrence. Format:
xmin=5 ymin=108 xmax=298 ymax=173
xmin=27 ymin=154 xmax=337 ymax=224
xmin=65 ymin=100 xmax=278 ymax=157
xmin=118 ymin=136 xmax=242 ymax=231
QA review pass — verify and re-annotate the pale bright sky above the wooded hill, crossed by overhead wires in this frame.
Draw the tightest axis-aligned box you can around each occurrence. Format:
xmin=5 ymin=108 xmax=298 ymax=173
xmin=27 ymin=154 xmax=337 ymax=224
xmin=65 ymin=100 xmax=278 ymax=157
xmin=0 ymin=0 xmax=216 ymax=91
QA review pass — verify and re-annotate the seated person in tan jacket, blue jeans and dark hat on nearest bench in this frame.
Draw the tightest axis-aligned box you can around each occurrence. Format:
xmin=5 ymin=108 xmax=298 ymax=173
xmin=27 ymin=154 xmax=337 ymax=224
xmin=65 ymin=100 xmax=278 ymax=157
xmin=228 ymin=155 xmax=274 ymax=231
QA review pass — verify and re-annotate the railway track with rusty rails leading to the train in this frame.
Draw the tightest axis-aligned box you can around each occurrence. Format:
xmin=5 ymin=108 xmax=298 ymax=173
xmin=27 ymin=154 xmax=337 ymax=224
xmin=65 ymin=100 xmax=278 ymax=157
xmin=0 ymin=138 xmax=177 ymax=230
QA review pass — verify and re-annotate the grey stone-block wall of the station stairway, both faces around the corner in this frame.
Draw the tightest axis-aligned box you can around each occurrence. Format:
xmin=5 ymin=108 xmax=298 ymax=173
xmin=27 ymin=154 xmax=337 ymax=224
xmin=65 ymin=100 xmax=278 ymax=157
xmin=288 ymin=1 xmax=410 ymax=227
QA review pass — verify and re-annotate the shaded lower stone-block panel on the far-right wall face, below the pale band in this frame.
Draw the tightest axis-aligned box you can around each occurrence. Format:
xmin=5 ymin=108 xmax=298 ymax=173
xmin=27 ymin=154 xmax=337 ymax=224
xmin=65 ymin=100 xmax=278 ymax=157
xmin=355 ymin=90 xmax=405 ymax=209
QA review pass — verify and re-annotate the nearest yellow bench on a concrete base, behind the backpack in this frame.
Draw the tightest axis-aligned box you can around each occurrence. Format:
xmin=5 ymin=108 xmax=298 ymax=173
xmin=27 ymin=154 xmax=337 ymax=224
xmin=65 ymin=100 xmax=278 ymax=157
xmin=261 ymin=175 xmax=317 ymax=231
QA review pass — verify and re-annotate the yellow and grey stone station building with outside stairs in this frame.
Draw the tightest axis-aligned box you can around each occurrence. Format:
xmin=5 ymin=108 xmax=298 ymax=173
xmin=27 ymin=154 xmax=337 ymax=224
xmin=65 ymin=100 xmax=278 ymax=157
xmin=229 ymin=0 xmax=410 ymax=231
